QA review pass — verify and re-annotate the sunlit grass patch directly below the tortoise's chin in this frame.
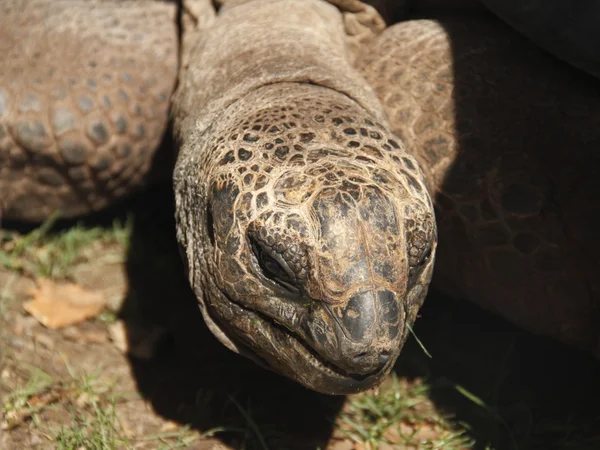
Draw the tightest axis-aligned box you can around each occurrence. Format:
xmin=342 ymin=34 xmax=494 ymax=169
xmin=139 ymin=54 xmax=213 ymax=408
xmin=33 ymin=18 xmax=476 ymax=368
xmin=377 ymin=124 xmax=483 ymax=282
xmin=339 ymin=376 xmax=474 ymax=450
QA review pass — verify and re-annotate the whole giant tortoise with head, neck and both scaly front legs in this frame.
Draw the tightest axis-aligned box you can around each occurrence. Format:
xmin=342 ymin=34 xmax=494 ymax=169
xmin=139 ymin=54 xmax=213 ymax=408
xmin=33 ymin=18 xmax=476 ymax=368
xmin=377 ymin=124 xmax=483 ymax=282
xmin=0 ymin=0 xmax=600 ymax=394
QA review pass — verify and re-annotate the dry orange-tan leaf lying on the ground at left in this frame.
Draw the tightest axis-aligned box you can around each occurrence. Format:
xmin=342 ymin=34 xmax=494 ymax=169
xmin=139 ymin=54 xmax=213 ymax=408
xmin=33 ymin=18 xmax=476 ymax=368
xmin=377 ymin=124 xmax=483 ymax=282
xmin=23 ymin=279 xmax=106 ymax=329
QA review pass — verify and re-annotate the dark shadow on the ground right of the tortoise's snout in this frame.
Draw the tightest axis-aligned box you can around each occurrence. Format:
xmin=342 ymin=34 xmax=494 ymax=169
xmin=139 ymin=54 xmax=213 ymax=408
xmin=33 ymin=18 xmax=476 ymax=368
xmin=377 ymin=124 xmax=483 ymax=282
xmin=396 ymin=293 xmax=600 ymax=450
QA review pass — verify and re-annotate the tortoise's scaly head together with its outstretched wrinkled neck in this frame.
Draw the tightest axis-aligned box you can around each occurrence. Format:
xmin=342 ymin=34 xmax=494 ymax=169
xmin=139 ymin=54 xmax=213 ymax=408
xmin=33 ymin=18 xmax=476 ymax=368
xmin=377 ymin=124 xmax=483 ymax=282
xmin=174 ymin=0 xmax=436 ymax=394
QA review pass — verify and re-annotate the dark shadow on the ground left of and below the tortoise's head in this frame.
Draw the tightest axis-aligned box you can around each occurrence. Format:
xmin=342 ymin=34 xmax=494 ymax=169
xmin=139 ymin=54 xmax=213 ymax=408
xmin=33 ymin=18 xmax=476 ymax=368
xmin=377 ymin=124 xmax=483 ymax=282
xmin=115 ymin=186 xmax=343 ymax=449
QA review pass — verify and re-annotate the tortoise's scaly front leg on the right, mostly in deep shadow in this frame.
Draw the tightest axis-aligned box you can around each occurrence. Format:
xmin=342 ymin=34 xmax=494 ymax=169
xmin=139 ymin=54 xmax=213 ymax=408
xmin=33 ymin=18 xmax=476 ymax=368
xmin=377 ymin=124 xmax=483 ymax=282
xmin=357 ymin=16 xmax=600 ymax=355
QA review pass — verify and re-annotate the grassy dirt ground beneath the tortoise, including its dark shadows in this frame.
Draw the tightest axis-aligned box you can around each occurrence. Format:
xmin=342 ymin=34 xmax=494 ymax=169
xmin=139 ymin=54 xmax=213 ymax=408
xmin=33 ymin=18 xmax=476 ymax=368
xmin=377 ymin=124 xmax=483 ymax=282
xmin=0 ymin=186 xmax=600 ymax=450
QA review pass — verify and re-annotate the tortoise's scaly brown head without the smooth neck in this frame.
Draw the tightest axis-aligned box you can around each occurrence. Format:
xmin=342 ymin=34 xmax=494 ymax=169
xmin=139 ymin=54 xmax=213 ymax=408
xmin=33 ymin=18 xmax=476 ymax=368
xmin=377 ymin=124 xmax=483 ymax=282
xmin=178 ymin=86 xmax=436 ymax=394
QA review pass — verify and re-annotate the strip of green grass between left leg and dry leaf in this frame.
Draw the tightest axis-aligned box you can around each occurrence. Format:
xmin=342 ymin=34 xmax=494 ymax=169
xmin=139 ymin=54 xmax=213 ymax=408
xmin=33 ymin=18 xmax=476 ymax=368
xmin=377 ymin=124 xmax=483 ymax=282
xmin=0 ymin=216 xmax=133 ymax=279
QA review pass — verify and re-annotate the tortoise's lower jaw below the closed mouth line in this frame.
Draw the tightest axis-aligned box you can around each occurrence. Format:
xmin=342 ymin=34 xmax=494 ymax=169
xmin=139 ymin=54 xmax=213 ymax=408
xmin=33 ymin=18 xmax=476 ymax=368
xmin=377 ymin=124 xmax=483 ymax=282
xmin=212 ymin=291 xmax=394 ymax=394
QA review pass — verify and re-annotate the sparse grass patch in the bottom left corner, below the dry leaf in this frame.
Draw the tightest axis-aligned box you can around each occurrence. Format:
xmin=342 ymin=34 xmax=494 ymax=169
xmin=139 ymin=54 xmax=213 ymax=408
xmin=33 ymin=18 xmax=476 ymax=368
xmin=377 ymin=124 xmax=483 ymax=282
xmin=3 ymin=365 xmax=207 ymax=450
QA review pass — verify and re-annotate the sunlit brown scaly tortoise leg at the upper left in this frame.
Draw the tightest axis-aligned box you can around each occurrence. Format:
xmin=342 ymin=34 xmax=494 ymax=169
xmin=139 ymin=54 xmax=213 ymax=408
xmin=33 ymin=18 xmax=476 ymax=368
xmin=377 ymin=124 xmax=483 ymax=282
xmin=0 ymin=0 xmax=177 ymax=221
